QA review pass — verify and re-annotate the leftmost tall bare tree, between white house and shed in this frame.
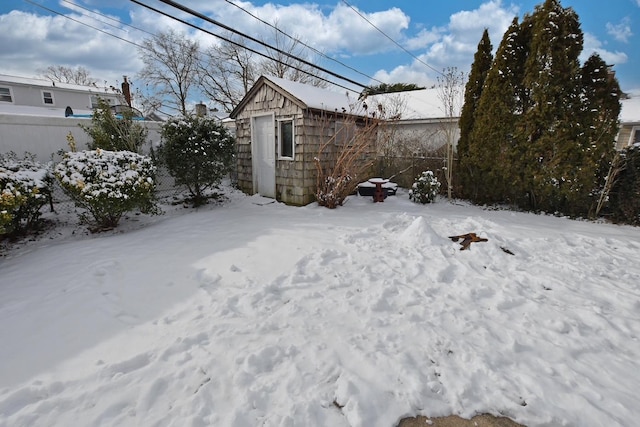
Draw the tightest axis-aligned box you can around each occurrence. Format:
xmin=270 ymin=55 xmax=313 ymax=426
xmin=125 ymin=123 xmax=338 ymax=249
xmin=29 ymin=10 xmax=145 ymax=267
xmin=139 ymin=30 xmax=200 ymax=115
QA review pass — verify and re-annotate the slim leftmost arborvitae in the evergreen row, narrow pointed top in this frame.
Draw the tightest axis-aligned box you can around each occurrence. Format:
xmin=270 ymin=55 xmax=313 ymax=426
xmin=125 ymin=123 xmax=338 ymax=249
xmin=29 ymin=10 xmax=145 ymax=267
xmin=457 ymin=29 xmax=493 ymax=197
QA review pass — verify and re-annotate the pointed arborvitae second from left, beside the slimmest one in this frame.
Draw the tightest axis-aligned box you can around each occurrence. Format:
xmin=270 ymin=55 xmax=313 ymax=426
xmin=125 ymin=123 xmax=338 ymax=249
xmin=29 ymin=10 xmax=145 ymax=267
xmin=465 ymin=18 xmax=526 ymax=203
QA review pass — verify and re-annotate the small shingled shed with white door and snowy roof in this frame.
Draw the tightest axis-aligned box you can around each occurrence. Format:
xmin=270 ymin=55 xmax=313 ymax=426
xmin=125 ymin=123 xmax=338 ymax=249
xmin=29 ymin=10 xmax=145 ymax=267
xmin=230 ymin=76 xmax=376 ymax=206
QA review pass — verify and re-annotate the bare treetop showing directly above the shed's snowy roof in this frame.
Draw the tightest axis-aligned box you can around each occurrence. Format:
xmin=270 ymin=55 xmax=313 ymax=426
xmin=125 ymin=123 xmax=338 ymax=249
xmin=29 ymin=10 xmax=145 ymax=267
xmin=260 ymin=22 xmax=327 ymax=87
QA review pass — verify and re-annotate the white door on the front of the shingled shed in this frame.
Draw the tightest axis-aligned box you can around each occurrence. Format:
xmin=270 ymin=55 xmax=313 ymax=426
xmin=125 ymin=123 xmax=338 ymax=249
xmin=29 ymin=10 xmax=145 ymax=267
xmin=251 ymin=115 xmax=276 ymax=198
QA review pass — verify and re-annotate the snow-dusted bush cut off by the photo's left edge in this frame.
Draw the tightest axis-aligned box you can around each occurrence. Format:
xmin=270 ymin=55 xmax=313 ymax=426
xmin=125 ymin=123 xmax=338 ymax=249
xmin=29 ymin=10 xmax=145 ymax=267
xmin=0 ymin=153 xmax=53 ymax=235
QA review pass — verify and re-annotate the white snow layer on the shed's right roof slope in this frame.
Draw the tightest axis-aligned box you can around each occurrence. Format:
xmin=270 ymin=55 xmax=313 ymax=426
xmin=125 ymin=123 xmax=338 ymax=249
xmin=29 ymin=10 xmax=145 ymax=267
xmin=263 ymin=76 xmax=359 ymax=112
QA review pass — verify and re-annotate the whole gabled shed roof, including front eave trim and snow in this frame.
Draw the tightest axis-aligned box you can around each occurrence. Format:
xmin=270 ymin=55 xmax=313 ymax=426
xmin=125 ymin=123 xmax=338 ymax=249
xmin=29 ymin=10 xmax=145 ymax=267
xmin=229 ymin=76 xmax=360 ymax=118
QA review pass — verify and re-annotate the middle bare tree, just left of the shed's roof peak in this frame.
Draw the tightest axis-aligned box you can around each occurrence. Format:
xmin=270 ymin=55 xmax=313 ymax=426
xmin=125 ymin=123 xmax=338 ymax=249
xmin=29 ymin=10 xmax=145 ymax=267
xmin=198 ymin=36 xmax=259 ymax=113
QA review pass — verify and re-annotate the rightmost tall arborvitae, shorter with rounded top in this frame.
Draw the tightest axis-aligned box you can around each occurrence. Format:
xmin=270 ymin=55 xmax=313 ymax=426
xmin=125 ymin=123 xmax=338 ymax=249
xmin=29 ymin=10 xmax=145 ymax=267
xmin=566 ymin=54 xmax=621 ymax=216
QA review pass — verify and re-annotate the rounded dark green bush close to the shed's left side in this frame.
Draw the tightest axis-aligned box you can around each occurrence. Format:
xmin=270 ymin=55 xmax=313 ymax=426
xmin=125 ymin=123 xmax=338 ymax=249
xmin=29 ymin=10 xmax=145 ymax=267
xmin=156 ymin=116 xmax=235 ymax=206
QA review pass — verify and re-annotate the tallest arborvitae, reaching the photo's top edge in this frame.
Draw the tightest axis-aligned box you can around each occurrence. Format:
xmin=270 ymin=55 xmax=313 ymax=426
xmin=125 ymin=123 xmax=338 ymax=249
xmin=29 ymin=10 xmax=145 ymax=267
xmin=522 ymin=0 xmax=583 ymax=211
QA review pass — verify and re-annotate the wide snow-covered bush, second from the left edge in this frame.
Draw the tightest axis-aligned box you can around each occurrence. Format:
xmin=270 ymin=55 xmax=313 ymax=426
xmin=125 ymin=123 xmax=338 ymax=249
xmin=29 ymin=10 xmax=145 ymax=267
xmin=55 ymin=149 xmax=160 ymax=231
